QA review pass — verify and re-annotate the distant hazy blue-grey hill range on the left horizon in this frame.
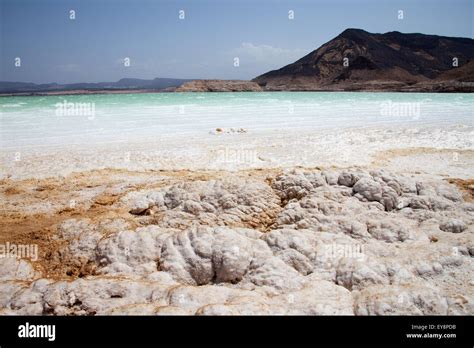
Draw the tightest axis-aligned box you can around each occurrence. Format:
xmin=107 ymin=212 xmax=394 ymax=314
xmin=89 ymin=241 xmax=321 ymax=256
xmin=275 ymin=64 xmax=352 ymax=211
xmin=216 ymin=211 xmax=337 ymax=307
xmin=0 ymin=78 xmax=191 ymax=93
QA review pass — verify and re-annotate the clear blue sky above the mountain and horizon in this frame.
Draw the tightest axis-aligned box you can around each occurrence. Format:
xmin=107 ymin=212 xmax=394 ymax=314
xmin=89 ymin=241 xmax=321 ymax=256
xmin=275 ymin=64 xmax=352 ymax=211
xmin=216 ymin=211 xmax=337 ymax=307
xmin=0 ymin=0 xmax=474 ymax=83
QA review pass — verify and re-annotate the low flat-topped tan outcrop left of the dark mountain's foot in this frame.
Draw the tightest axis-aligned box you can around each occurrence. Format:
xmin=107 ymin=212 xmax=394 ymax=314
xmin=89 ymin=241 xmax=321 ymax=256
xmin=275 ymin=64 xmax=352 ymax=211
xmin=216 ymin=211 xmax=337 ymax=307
xmin=175 ymin=80 xmax=262 ymax=92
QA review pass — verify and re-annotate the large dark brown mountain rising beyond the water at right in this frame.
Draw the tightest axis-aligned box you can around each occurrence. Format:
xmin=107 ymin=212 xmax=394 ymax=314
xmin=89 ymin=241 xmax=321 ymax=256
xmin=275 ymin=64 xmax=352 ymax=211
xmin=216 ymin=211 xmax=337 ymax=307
xmin=253 ymin=29 xmax=474 ymax=91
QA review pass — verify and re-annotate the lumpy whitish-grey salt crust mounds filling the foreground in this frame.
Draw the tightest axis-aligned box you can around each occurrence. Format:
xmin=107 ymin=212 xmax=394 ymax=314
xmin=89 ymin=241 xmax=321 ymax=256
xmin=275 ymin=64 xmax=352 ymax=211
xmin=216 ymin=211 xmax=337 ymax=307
xmin=0 ymin=168 xmax=474 ymax=315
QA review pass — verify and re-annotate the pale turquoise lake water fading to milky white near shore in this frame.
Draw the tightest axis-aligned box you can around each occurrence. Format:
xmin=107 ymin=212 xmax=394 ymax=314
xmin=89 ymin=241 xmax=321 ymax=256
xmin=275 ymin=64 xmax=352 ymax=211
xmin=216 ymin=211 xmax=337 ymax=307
xmin=0 ymin=92 xmax=474 ymax=148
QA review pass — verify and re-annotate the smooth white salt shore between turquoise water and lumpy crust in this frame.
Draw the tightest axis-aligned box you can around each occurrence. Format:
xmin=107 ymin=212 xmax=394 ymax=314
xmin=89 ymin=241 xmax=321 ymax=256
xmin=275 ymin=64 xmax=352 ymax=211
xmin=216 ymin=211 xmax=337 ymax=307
xmin=0 ymin=123 xmax=474 ymax=179
